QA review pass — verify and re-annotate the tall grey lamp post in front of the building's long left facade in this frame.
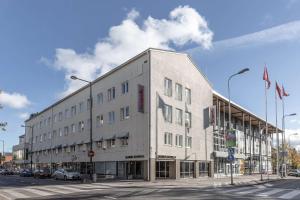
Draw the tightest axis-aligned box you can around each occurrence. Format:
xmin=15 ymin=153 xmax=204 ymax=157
xmin=70 ymin=76 xmax=94 ymax=180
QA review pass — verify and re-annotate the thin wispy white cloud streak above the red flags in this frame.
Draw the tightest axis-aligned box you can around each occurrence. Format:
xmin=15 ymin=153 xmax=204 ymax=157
xmin=188 ymin=20 xmax=300 ymax=53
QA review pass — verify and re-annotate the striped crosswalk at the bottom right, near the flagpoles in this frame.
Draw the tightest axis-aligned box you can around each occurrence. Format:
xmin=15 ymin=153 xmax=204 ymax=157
xmin=207 ymin=185 xmax=300 ymax=199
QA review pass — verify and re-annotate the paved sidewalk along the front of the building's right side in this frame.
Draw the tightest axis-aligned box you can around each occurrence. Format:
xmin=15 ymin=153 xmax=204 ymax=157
xmin=92 ymin=174 xmax=281 ymax=188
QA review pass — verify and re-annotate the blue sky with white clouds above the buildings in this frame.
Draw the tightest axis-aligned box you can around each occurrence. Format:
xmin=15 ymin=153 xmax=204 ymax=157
xmin=0 ymin=0 xmax=300 ymax=151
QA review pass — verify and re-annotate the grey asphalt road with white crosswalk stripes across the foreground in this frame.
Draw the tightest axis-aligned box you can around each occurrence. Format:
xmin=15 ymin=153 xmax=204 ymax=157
xmin=0 ymin=176 xmax=300 ymax=200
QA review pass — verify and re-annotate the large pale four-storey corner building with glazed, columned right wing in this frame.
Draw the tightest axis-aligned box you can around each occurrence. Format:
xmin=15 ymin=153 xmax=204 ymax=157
xmin=25 ymin=49 xmax=274 ymax=180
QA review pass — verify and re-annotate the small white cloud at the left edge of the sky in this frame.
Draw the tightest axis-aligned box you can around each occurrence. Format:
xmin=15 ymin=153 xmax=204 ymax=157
xmin=0 ymin=91 xmax=31 ymax=109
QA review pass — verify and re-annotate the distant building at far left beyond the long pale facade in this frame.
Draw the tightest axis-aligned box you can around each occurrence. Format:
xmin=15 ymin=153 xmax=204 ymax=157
xmin=13 ymin=134 xmax=29 ymax=168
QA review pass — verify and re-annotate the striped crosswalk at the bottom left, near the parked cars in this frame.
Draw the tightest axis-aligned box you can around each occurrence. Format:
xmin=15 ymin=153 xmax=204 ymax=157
xmin=0 ymin=183 xmax=110 ymax=200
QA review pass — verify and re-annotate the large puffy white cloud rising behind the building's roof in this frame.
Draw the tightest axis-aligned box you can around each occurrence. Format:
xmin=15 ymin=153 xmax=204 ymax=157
xmin=45 ymin=6 xmax=213 ymax=96
